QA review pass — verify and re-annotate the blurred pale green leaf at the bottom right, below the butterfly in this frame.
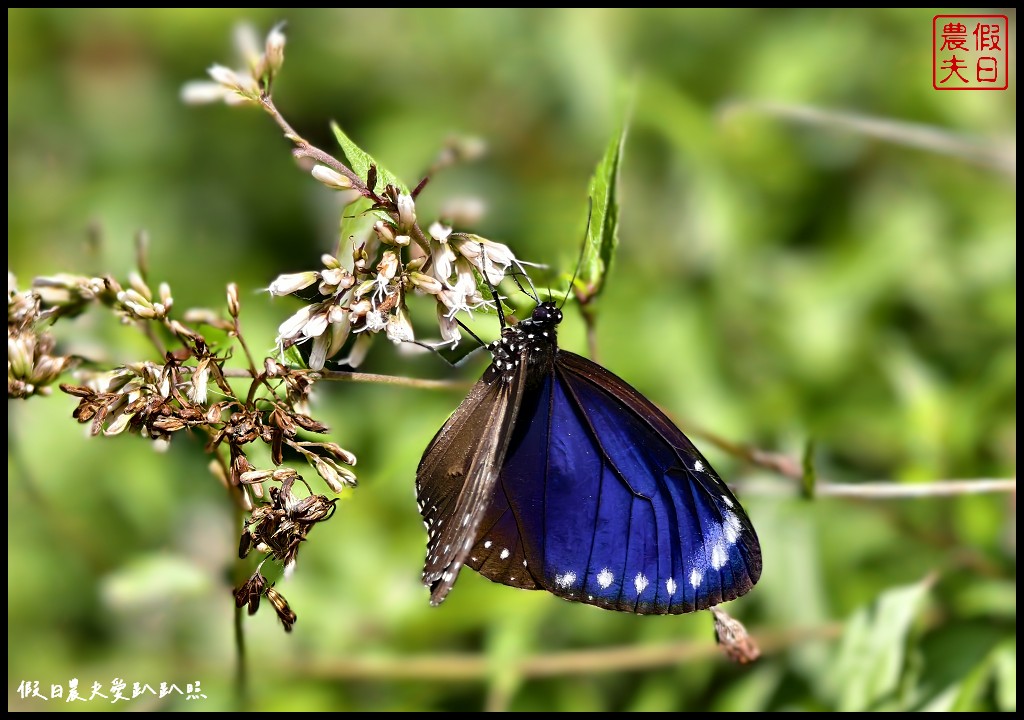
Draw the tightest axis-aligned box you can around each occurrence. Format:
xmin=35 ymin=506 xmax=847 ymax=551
xmin=830 ymin=578 xmax=933 ymax=712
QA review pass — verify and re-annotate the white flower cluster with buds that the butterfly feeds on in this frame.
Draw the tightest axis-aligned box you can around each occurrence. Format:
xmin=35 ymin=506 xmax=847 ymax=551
xmin=183 ymin=26 xmax=536 ymax=371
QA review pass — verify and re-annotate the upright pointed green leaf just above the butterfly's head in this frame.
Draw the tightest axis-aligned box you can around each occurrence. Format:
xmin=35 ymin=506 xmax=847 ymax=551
xmin=574 ymin=122 xmax=627 ymax=302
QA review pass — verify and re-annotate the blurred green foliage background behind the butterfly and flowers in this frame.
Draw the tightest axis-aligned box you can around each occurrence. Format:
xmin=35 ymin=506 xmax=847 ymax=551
xmin=7 ymin=9 xmax=1017 ymax=711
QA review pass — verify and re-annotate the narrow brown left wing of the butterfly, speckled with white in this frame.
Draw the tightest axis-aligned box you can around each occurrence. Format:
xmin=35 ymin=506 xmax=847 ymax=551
xmin=416 ymin=364 xmax=526 ymax=604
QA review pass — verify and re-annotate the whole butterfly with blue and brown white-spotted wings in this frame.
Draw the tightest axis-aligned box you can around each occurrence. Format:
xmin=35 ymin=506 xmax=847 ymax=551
xmin=416 ymin=301 xmax=761 ymax=615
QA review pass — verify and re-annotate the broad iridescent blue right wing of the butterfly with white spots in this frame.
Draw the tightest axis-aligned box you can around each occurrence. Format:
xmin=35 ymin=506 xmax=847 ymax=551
xmin=468 ymin=351 xmax=761 ymax=613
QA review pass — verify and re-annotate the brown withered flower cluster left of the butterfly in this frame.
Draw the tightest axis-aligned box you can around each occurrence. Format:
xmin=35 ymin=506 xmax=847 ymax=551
xmin=43 ymin=262 xmax=355 ymax=629
